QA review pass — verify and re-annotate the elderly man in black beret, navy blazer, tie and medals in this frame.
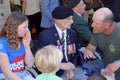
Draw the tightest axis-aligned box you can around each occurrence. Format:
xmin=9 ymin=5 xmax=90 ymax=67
xmin=39 ymin=6 xmax=87 ymax=80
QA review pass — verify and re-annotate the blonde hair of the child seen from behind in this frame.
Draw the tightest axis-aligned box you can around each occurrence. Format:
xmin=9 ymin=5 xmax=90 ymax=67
xmin=35 ymin=45 xmax=63 ymax=73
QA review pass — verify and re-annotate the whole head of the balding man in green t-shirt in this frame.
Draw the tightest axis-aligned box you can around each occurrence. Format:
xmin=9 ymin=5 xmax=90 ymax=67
xmin=92 ymin=7 xmax=114 ymax=35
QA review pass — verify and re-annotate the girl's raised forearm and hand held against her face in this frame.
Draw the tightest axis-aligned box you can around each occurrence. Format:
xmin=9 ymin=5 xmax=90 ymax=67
xmin=23 ymin=31 xmax=34 ymax=68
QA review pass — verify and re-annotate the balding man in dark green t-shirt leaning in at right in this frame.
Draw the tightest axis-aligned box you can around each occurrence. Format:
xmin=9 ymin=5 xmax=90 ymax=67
xmin=84 ymin=7 xmax=120 ymax=80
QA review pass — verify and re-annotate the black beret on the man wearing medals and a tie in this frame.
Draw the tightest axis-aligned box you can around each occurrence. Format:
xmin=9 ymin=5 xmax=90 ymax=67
xmin=52 ymin=6 xmax=73 ymax=19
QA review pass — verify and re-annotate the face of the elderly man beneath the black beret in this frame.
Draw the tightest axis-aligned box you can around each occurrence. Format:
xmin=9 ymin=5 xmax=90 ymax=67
xmin=55 ymin=16 xmax=73 ymax=30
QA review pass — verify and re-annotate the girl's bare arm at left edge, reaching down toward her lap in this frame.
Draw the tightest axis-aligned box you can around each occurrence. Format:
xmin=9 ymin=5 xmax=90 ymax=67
xmin=0 ymin=52 xmax=22 ymax=80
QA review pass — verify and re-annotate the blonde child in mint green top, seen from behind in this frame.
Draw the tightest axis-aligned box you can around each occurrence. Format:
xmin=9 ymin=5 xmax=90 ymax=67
xmin=35 ymin=45 xmax=63 ymax=80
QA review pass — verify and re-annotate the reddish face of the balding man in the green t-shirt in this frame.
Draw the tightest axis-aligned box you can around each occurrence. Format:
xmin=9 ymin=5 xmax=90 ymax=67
xmin=91 ymin=14 xmax=107 ymax=33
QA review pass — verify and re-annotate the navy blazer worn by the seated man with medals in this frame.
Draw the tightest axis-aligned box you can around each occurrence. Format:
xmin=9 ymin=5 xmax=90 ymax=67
xmin=39 ymin=26 xmax=78 ymax=76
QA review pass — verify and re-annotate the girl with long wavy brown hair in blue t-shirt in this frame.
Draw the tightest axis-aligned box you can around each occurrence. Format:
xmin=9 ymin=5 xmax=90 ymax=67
xmin=0 ymin=12 xmax=34 ymax=80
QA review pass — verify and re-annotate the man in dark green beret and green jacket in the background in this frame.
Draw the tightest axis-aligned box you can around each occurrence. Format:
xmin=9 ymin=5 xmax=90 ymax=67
xmin=68 ymin=0 xmax=92 ymax=46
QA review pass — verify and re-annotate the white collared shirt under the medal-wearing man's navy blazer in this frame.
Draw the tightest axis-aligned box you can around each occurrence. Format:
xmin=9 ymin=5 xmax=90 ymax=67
xmin=55 ymin=24 xmax=68 ymax=61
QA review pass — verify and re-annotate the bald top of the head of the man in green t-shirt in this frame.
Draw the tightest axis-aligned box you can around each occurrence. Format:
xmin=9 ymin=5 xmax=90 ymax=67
xmin=93 ymin=7 xmax=114 ymax=22
